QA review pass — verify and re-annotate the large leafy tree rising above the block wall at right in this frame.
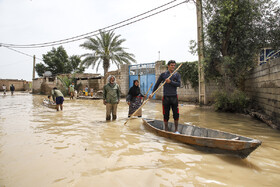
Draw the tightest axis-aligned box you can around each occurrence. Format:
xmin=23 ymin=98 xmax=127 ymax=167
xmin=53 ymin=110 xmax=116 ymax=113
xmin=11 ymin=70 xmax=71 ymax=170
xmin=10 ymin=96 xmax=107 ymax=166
xmin=203 ymin=0 xmax=280 ymax=88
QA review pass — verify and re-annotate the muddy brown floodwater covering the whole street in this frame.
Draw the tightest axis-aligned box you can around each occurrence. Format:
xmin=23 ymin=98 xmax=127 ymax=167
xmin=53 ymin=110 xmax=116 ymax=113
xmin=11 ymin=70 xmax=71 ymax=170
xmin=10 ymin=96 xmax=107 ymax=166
xmin=0 ymin=93 xmax=280 ymax=187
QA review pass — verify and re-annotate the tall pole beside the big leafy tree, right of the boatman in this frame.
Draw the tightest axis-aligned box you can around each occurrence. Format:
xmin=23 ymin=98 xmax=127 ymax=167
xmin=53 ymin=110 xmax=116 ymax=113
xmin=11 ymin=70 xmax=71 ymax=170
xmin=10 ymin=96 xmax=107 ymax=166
xmin=196 ymin=0 xmax=207 ymax=105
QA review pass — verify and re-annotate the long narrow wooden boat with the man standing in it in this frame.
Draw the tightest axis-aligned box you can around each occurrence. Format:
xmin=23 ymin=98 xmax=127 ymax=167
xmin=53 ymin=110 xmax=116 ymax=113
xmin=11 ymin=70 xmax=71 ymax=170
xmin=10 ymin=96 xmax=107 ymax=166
xmin=143 ymin=119 xmax=262 ymax=158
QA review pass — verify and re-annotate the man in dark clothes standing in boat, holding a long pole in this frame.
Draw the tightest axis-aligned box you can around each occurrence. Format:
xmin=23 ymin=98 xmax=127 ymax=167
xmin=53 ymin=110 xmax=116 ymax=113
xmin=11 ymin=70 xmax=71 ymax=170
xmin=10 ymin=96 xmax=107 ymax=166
xmin=149 ymin=60 xmax=181 ymax=134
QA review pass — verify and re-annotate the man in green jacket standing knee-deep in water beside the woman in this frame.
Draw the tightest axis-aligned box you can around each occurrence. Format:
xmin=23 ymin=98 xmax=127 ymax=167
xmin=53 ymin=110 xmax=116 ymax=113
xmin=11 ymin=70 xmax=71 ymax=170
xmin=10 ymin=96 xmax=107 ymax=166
xmin=103 ymin=75 xmax=121 ymax=120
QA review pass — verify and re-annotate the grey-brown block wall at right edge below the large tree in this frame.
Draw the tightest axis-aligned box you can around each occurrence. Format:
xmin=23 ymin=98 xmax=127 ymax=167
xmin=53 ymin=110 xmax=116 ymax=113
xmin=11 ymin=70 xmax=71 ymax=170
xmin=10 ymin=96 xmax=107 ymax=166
xmin=245 ymin=58 xmax=280 ymax=124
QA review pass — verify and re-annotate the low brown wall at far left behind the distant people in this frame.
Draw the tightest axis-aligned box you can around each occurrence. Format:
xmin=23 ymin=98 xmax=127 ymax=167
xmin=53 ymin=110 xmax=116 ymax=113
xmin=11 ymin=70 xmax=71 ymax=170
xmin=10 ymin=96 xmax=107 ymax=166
xmin=0 ymin=79 xmax=30 ymax=91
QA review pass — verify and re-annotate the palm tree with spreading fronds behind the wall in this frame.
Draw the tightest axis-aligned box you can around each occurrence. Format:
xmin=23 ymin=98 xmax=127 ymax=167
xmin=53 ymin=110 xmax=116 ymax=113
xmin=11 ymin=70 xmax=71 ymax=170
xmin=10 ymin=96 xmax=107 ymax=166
xmin=80 ymin=31 xmax=136 ymax=81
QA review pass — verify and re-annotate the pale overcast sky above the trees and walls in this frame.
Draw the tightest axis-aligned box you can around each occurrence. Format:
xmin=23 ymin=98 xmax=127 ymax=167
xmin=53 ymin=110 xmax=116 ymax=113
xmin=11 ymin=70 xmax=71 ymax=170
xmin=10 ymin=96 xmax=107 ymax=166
xmin=0 ymin=0 xmax=197 ymax=80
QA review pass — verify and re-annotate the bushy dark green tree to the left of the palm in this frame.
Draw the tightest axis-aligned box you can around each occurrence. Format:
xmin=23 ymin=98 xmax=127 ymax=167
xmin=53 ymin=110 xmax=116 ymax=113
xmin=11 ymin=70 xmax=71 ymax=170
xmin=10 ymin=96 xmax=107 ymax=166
xmin=35 ymin=46 xmax=85 ymax=76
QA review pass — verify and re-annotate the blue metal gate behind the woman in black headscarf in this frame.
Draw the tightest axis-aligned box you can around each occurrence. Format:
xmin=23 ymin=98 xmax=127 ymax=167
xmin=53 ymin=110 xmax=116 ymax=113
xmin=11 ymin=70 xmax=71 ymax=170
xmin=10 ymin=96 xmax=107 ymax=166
xmin=128 ymin=63 xmax=156 ymax=98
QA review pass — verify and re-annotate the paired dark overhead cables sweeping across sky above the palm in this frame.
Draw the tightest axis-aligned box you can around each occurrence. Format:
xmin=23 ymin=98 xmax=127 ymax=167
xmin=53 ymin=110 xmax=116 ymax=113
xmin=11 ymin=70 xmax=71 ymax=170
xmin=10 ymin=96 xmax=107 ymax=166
xmin=0 ymin=0 xmax=190 ymax=48
